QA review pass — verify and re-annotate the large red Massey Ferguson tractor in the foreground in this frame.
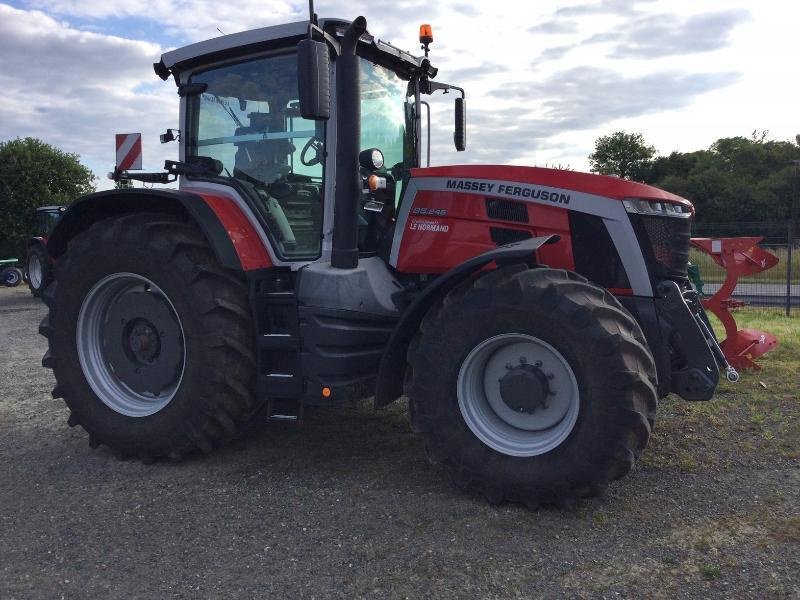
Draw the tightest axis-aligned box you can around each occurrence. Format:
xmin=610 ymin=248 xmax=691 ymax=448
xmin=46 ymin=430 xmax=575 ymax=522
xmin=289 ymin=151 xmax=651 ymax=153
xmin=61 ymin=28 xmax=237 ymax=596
xmin=40 ymin=11 xmax=734 ymax=505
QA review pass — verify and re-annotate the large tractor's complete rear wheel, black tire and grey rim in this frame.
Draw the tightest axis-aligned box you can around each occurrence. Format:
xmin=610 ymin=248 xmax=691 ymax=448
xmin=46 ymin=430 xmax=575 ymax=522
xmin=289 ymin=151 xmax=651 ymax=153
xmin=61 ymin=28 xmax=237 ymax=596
xmin=39 ymin=213 xmax=259 ymax=462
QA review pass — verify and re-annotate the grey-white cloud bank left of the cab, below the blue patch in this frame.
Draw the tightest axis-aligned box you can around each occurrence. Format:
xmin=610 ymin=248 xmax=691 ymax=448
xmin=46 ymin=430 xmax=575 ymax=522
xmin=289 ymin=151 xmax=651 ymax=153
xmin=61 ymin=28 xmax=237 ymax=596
xmin=0 ymin=4 xmax=177 ymax=182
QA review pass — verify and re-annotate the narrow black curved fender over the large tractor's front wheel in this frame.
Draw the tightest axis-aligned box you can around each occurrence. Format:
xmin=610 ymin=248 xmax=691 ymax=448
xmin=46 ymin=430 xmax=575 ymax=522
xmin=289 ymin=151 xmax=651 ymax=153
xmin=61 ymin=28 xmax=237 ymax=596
xmin=375 ymin=235 xmax=560 ymax=408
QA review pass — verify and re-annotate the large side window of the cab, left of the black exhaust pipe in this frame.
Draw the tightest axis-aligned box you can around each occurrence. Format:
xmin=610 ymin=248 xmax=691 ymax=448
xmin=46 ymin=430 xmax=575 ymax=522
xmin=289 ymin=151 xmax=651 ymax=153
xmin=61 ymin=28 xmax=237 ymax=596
xmin=187 ymin=54 xmax=325 ymax=260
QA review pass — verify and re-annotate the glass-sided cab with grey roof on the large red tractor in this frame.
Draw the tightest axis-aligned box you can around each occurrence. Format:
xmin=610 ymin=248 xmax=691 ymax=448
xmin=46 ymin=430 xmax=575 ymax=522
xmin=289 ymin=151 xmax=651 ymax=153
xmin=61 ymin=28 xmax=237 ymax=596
xmin=155 ymin=19 xmax=459 ymax=266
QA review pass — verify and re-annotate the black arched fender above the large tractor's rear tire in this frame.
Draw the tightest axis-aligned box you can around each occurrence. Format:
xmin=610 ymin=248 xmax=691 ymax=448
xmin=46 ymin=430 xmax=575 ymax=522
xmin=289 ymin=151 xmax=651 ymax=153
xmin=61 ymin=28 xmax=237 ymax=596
xmin=47 ymin=189 xmax=242 ymax=270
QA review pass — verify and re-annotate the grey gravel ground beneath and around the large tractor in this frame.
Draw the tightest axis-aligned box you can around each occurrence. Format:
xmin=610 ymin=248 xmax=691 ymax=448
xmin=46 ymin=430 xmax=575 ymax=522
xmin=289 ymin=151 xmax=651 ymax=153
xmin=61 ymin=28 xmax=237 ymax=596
xmin=0 ymin=288 xmax=800 ymax=599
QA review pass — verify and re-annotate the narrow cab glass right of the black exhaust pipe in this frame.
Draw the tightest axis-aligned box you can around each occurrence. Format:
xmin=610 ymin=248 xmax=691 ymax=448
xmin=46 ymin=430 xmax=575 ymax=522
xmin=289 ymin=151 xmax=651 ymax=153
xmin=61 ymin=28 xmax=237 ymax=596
xmin=361 ymin=59 xmax=416 ymax=203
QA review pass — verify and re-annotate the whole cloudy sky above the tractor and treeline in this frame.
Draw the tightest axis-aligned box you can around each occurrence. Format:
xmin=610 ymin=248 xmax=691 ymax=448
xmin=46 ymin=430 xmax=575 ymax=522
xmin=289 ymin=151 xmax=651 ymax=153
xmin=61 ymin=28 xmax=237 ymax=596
xmin=0 ymin=0 xmax=800 ymax=189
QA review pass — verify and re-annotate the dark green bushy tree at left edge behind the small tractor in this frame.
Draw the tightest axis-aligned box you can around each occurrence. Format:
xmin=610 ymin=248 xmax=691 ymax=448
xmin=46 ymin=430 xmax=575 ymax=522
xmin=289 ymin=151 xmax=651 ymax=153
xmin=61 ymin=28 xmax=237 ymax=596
xmin=0 ymin=137 xmax=95 ymax=258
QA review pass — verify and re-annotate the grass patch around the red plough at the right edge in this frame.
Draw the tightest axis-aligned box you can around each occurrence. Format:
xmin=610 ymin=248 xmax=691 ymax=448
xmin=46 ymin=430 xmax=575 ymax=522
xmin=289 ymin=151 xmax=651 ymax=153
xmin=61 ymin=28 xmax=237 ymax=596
xmin=641 ymin=308 xmax=800 ymax=473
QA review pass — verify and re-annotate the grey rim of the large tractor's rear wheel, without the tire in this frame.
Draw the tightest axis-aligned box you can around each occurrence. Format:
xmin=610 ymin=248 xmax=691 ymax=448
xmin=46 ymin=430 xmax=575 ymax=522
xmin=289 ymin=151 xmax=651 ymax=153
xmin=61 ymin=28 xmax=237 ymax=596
xmin=75 ymin=273 xmax=186 ymax=417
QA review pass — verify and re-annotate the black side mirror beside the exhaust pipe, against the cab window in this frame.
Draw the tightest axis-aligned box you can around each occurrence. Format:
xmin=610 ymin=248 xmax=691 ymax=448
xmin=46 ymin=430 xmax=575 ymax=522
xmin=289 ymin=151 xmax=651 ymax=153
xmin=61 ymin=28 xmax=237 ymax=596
xmin=297 ymin=40 xmax=331 ymax=121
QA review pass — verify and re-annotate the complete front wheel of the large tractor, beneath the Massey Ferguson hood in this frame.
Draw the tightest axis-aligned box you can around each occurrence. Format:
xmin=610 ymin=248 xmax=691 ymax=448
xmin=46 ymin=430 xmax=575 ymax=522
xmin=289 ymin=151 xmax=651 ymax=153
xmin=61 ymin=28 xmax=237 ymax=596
xmin=408 ymin=267 xmax=657 ymax=506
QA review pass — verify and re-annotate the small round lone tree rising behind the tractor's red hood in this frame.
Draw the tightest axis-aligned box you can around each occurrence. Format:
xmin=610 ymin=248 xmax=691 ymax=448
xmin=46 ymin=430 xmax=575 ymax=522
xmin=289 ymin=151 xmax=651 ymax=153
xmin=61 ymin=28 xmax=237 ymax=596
xmin=589 ymin=131 xmax=656 ymax=180
